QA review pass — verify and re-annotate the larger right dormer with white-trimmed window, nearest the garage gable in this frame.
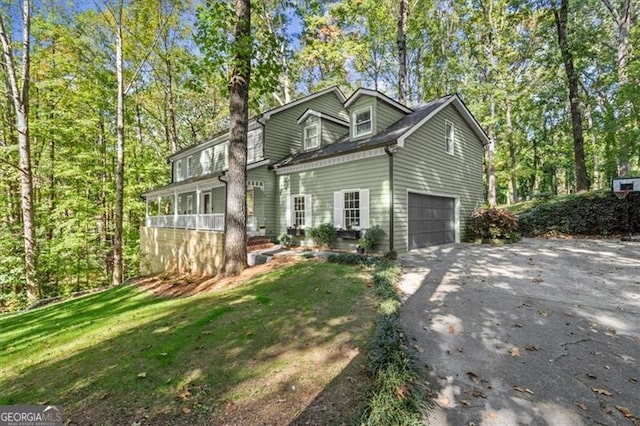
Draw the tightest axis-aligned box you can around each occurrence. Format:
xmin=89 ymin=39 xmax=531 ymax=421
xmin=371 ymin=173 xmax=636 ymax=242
xmin=344 ymin=88 xmax=412 ymax=140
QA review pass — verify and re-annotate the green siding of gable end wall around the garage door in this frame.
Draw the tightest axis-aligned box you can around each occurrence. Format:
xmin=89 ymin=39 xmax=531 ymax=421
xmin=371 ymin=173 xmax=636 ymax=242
xmin=393 ymin=106 xmax=484 ymax=253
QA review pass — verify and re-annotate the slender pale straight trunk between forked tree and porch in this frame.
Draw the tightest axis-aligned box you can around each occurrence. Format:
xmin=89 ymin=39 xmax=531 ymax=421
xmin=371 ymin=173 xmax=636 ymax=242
xmin=112 ymin=0 xmax=124 ymax=285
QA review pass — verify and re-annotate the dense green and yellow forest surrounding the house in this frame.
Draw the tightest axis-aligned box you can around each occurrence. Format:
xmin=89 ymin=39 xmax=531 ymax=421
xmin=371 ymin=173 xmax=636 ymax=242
xmin=0 ymin=0 xmax=640 ymax=309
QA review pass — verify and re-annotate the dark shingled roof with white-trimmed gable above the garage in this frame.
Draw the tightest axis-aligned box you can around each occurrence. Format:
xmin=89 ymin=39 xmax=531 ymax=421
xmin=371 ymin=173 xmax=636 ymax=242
xmin=273 ymin=94 xmax=489 ymax=168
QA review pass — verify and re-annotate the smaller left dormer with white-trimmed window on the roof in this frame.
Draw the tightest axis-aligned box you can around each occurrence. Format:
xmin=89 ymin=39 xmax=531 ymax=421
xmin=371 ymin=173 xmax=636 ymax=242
xmin=297 ymin=109 xmax=349 ymax=151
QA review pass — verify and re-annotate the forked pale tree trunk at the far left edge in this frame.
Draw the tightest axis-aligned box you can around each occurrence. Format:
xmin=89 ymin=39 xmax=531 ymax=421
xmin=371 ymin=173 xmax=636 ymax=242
xmin=0 ymin=0 xmax=40 ymax=300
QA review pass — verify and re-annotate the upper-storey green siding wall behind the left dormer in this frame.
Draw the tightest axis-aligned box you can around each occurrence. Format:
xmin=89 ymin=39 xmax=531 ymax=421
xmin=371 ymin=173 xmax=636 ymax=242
xmin=264 ymin=92 xmax=343 ymax=161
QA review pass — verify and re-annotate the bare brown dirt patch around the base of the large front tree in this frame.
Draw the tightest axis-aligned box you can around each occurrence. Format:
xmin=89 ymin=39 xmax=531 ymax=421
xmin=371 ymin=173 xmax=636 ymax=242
xmin=136 ymin=256 xmax=301 ymax=297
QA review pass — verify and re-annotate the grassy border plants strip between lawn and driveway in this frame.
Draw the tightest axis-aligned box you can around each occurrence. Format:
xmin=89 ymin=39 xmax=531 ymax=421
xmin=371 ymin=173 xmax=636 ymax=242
xmin=329 ymin=254 xmax=426 ymax=426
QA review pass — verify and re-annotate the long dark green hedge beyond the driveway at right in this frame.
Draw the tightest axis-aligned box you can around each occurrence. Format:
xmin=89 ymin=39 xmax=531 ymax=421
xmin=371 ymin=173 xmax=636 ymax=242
xmin=518 ymin=191 xmax=640 ymax=236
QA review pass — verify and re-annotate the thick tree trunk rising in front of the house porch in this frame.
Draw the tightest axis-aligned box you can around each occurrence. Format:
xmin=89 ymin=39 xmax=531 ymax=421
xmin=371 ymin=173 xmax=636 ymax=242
xmin=221 ymin=0 xmax=252 ymax=276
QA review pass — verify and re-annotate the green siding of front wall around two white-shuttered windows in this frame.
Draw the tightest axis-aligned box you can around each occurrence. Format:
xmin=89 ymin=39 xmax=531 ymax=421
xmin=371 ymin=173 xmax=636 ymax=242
xmin=278 ymin=155 xmax=390 ymax=251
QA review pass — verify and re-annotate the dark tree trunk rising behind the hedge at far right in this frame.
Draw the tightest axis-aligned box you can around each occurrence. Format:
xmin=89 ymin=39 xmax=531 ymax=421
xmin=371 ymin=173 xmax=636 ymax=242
xmin=553 ymin=0 xmax=589 ymax=191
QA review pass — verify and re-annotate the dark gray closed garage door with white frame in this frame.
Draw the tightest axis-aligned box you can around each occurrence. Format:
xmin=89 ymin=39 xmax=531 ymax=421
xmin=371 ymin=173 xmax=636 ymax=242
xmin=408 ymin=192 xmax=456 ymax=250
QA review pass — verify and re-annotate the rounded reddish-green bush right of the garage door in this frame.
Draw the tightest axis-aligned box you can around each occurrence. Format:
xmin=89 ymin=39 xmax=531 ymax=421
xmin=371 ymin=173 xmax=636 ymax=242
xmin=467 ymin=208 xmax=518 ymax=242
